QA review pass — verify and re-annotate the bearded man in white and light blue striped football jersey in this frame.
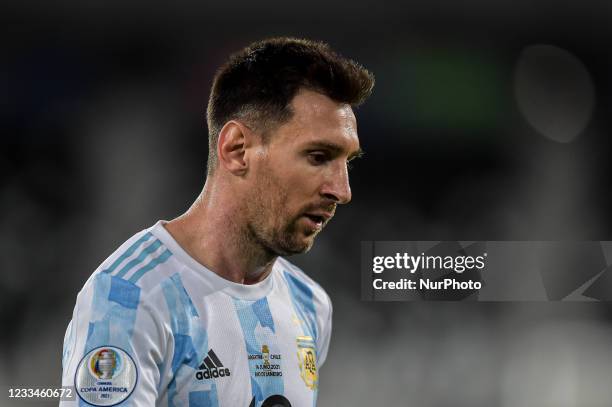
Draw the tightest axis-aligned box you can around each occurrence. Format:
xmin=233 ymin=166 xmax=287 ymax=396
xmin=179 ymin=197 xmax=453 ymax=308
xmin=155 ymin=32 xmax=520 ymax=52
xmin=63 ymin=38 xmax=374 ymax=407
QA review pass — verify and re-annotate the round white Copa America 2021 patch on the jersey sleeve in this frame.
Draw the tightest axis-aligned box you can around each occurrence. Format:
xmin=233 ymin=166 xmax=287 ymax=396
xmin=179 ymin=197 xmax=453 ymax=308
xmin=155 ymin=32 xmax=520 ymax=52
xmin=74 ymin=346 xmax=138 ymax=406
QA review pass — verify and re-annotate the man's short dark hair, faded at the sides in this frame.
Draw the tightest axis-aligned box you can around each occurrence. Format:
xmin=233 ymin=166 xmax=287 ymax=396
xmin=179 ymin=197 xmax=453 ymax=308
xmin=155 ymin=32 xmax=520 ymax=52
xmin=206 ymin=37 xmax=374 ymax=174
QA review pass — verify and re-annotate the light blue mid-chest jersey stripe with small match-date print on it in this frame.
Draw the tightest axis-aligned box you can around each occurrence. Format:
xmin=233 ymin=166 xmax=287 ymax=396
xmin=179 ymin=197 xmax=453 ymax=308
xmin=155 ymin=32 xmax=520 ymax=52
xmin=234 ymin=297 xmax=284 ymax=407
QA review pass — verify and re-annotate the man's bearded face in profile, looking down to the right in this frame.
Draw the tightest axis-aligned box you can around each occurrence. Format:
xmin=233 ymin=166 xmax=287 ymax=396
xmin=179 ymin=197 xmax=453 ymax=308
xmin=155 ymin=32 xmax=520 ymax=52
xmin=247 ymin=90 xmax=361 ymax=255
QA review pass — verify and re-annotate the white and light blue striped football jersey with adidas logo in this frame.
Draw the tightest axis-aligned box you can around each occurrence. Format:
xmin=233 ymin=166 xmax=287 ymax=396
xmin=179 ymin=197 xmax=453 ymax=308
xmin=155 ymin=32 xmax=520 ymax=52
xmin=60 ymin=221 xmax=332 ymax=407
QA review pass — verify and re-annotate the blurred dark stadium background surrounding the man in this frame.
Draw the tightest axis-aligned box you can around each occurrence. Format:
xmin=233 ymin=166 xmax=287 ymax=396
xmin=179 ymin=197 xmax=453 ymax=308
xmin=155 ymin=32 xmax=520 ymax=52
xmin=0 ymin=0 xmax=612 ymax=407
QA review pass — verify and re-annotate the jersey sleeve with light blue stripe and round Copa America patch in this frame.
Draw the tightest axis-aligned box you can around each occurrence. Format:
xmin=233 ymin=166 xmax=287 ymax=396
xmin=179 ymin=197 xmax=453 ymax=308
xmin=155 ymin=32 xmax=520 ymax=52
xmin=60 ymin=272 xmax=167 ymax=407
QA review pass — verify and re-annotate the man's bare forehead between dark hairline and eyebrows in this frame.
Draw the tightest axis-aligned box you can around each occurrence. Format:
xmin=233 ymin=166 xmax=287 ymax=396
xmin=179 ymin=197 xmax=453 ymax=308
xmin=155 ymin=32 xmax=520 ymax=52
xmin=278 ymin=90 xmax=359 ymax=153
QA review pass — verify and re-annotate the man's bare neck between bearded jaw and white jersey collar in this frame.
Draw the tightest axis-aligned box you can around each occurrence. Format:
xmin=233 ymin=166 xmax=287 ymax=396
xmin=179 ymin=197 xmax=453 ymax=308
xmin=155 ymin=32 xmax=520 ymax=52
xmin=165 ymin=182 xmax=277 ymax=284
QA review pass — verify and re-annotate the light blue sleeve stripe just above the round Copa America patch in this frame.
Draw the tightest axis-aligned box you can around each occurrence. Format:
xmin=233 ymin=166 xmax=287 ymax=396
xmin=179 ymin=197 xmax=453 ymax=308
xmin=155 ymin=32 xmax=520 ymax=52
xmin=84 ymin=273 xmax=140 ymax=353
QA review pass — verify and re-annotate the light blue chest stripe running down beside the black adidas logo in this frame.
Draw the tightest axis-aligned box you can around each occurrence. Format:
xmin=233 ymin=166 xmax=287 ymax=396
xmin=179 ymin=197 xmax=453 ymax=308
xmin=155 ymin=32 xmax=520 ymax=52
xmin=161 ymin=273 xmax=218 ymax=407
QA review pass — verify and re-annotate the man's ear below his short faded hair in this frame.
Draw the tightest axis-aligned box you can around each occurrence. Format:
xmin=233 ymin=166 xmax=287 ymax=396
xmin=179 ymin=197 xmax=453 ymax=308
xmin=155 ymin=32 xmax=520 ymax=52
xmin=217 ymin=120 xmax=253 ymax=176
